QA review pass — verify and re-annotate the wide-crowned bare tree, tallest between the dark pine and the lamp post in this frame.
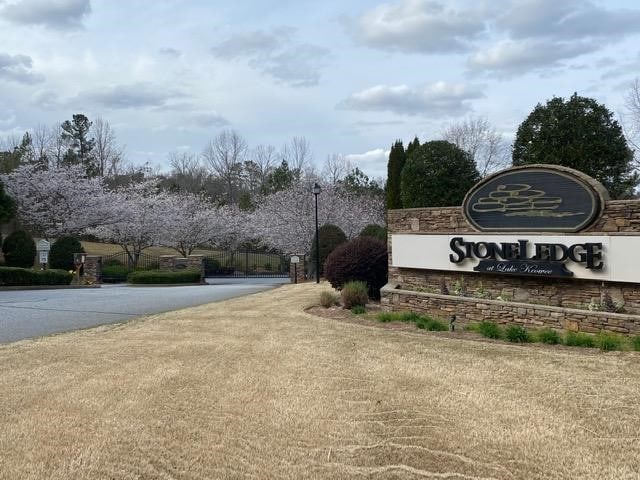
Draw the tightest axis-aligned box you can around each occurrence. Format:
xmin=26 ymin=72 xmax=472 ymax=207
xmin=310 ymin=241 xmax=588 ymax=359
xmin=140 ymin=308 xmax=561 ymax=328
xmin=202 ymin=130 xmax=248 ymax=204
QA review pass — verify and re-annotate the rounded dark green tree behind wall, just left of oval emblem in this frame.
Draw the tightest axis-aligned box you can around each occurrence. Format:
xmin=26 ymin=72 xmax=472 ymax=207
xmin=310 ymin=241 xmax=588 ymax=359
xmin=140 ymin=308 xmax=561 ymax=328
xmin=400 ymin=140 xmax=480 ymax=208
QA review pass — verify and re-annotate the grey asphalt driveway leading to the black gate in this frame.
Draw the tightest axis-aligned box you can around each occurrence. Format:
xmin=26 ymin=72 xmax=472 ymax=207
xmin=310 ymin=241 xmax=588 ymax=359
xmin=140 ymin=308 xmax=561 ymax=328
xmin=0 ymin=278 xmax=288 ymax=344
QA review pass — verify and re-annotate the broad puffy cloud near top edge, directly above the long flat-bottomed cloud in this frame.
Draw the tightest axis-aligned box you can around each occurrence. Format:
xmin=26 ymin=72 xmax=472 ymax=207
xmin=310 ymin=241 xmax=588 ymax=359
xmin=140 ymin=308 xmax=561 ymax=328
xmin=346 ymin=0 xmax=485 ymax=53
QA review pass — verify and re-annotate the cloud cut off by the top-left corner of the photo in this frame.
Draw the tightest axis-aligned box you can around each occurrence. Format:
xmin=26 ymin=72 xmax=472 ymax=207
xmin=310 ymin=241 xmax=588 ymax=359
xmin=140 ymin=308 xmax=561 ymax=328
xmin=0 ymin=0 xmax=91 ymax=30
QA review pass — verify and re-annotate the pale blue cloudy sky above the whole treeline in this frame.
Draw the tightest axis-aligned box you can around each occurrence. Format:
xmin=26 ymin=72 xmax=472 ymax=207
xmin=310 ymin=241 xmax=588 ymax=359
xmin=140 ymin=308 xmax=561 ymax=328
xmin=0 ymin=0 xmax=640 ymax=176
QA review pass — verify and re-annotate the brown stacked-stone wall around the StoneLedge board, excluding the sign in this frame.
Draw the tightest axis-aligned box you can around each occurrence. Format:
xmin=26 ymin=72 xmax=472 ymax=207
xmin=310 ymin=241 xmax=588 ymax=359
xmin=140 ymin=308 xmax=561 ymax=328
xmin=382 ymin=200 xmax=640 ymax=333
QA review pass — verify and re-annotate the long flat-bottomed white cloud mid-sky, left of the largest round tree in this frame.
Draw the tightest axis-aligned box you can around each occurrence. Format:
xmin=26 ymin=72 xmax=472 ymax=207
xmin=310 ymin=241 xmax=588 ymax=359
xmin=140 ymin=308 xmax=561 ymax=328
xmin=338 ymin=82 xmax=483 ymax=116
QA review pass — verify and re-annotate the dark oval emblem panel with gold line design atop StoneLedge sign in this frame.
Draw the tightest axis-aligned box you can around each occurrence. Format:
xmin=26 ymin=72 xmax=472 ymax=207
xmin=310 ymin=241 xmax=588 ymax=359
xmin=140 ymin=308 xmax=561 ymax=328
xmin=462 ymin=165 xmax=606 ymax=232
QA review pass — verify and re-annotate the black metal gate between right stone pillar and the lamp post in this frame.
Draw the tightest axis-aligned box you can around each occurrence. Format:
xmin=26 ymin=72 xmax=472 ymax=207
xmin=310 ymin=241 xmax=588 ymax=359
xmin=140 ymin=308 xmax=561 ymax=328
xmin=204 ymin=251 xmax=289 ymax=278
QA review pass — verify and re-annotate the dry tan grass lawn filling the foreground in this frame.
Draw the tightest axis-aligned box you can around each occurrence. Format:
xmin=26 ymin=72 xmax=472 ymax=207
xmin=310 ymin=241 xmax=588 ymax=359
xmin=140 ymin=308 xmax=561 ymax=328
xmin=0 ymin=284 xmax=640 ymax=479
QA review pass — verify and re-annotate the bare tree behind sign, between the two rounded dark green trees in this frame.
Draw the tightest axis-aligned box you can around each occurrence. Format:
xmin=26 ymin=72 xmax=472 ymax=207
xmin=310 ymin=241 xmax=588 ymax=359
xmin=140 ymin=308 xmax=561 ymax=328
xmin=442 ymin=117 xmax=509 ymax=177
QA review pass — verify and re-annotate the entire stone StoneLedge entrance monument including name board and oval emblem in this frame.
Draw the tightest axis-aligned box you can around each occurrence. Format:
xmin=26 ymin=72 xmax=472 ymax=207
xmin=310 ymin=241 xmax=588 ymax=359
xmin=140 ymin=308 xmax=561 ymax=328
xmin=381 ymin=165 xmax=640 ymax=334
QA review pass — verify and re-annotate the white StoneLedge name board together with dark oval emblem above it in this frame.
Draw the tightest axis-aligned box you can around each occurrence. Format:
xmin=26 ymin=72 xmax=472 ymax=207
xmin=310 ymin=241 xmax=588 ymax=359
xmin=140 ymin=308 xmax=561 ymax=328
xmin=392 ymin=165 xmax=640 ymax=282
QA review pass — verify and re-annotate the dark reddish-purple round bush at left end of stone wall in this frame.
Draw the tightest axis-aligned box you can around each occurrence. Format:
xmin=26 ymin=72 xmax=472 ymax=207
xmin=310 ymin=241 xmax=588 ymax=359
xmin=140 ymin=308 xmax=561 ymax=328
xmin=324 ymin=237 xmax=389 ymax=299
